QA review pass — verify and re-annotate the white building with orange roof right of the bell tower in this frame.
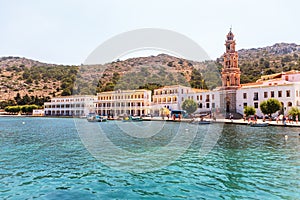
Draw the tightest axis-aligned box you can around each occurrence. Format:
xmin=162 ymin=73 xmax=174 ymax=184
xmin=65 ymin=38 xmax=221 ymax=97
xmin=236 ymin=71 xmax=300 ymax=116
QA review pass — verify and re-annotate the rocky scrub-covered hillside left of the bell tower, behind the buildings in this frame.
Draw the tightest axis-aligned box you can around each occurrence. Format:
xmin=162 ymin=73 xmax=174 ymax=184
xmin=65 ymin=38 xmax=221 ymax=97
xmin=0 ymin=54 xmax=219 ymax=107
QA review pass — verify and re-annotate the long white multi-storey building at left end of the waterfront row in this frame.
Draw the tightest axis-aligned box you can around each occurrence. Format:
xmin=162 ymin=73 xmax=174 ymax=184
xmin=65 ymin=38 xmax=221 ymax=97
xmin=44 ymin=95 xmax=96 ymax=116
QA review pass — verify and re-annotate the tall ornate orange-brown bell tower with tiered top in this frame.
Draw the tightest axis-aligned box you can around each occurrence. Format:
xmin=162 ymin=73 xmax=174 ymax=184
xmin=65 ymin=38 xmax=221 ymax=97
xmin=220 ymin=28 xmax=241 ymax=114
